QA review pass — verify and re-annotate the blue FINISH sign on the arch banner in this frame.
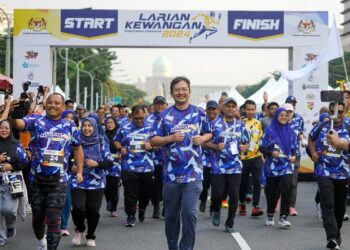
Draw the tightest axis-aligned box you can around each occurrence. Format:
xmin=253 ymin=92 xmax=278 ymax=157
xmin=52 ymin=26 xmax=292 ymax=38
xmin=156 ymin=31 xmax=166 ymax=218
xmin=227 ymin=11 xmax=284 ymax=40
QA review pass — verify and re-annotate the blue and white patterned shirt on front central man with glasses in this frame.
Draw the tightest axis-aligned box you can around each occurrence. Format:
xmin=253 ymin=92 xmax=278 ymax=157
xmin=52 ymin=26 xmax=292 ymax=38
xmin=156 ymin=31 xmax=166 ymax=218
xmin=154 ymin=104 xmax=211 ymax=183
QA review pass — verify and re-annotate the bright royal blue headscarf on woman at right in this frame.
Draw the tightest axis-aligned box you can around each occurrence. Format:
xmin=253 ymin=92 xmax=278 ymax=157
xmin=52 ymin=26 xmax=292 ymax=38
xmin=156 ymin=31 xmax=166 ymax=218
xmin=267 ymin=108 xmax=296 ymax=156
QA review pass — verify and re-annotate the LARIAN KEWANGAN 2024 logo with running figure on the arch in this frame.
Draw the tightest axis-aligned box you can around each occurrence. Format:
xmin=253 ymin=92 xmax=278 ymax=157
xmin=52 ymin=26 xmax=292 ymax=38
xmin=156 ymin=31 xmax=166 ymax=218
xmin=123 ymin=11 xmax=222 ymax=43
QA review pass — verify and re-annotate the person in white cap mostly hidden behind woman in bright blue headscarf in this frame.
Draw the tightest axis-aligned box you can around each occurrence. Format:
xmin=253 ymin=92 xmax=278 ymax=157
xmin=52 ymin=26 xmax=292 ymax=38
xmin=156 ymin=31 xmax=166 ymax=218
xmin=286 ymin=96 xmax=307 ymax=216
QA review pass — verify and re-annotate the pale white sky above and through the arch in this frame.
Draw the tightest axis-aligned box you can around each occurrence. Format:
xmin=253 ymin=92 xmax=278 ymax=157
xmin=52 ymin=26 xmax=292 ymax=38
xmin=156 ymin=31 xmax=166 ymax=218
xmin=0 ymin=0 xmax=343 ymax=86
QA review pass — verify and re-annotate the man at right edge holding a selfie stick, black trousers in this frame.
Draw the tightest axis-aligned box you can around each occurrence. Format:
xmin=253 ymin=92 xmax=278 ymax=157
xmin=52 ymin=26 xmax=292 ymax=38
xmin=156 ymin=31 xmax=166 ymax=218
xmin=309 ymin=102 xmax=350 ymax=249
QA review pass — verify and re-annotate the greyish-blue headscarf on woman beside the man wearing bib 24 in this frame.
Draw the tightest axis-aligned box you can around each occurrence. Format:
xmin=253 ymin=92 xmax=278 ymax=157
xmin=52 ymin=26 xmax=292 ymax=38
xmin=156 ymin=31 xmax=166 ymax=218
xmin=81 ymin=117 xmax=102 ymax=161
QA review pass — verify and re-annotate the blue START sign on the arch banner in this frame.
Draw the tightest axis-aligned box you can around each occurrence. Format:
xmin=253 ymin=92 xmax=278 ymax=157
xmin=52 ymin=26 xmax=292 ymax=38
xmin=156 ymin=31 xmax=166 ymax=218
xmin=61 ymin=9 xmax=118 ymax=38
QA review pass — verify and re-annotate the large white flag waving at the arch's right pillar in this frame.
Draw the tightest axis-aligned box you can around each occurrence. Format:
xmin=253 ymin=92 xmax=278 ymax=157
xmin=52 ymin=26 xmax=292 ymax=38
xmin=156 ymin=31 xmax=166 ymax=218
xmin=281 ymin=17 xmax=344 ymax=81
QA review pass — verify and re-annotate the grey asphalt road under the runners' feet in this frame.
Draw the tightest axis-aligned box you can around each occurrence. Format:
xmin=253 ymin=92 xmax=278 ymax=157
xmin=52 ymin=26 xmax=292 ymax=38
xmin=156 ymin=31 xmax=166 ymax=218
xmin=2 ymin=183 xmax=350 ymax=250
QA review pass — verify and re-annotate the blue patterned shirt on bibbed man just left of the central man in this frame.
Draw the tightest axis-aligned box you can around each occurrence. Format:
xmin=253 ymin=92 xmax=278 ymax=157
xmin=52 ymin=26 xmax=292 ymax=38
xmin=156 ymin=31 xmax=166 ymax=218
xmin=115 ymin=122 xmax=154 ymax=173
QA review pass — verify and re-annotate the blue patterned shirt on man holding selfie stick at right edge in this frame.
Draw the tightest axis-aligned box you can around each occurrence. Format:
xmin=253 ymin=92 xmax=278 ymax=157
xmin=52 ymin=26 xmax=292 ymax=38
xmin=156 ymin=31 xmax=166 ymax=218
xmin=309 ymin=122 xmax=350 ymax=179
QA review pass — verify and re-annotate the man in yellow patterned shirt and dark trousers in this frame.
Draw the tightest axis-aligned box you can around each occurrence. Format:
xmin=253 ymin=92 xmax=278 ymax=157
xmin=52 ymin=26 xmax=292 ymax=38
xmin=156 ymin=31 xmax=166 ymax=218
xmin=239 ymin=100 xmax=264 ymax=216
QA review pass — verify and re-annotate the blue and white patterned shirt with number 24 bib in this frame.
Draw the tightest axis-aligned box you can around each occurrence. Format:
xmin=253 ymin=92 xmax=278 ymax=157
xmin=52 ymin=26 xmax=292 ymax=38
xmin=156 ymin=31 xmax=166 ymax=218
xmin=23 ymin=114 xmax=80 ymax=182
